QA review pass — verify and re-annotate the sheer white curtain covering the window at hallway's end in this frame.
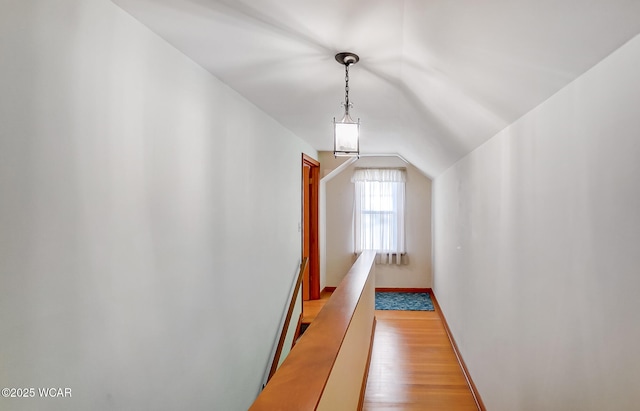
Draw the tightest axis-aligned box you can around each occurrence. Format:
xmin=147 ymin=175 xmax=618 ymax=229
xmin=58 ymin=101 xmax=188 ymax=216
xmin=351 ymin=169 xmax=406 ymax=264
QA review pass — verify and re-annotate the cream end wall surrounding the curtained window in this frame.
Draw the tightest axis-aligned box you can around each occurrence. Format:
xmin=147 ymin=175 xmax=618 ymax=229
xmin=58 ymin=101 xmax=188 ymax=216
xmin=320 ymin=152 xmax=432 ymax=288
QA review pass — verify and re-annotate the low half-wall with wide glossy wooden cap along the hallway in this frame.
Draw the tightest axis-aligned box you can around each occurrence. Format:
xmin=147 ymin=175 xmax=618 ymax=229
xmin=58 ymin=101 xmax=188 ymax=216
xmin=250 ymin=252 xmax=375 ymax=411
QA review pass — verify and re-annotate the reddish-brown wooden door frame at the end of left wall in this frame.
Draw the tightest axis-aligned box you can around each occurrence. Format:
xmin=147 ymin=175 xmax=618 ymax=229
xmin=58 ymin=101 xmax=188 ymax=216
xmin=300 ymin=153 xmax=320 ymax=300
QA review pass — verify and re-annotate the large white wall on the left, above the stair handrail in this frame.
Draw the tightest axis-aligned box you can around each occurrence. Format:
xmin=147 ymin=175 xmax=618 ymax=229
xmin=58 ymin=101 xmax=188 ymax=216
xmin=0 ymin=0 xmax=317 ymax=410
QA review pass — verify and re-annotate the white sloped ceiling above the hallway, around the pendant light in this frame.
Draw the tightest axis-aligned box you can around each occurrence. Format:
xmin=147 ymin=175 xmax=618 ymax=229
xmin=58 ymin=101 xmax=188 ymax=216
xmin=113 ymin=0 xmax=640 ymax=177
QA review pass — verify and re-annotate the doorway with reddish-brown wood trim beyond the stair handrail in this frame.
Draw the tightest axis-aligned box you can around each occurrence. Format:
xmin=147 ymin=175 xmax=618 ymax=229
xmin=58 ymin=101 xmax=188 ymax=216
xmin=302 ymin=154 xmax=320 ymax=301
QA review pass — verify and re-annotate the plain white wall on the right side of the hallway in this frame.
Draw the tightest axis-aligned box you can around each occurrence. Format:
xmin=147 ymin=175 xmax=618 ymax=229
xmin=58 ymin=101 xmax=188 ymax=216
xmin=434 ymin=33 xmax=640 ymax=411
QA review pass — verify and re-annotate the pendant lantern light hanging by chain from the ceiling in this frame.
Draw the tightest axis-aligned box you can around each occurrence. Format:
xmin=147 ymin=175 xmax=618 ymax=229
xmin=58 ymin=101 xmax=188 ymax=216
xmin=333 ymin=52 xmax=360 ymax=157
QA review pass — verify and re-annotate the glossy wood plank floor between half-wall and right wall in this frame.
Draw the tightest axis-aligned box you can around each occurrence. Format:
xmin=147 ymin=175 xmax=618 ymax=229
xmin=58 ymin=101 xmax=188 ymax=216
xmin=363 ymin=311 xmax=478 ymax=411
